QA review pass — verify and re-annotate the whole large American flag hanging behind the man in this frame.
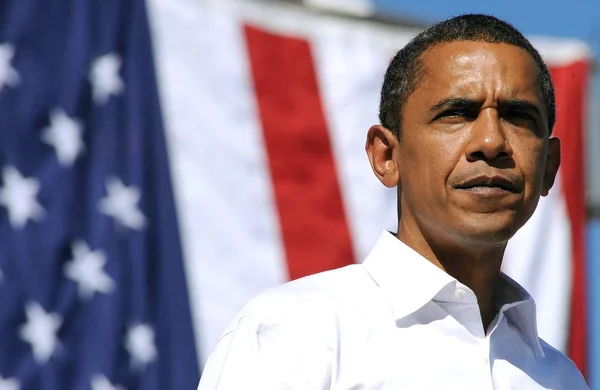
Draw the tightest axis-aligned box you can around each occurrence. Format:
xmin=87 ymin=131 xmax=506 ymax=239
xmin=0 ymin=0 xmax=590 ymax=390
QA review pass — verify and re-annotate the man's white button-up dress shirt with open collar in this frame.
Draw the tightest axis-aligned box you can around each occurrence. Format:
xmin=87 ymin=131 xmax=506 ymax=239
xmin=198 ymin=231 xmax=588 ymax=390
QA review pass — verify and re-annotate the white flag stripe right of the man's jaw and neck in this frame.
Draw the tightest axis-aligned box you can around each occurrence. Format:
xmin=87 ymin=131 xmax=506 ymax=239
xmin=503 ymin=173 xmax=573 ymax=352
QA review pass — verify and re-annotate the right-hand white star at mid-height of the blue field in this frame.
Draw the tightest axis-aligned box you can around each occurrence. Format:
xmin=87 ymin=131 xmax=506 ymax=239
xmin=99 ymin=177 xmax=146 ymax=230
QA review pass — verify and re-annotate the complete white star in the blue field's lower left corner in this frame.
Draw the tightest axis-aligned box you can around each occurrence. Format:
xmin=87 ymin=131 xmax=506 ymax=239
xmin=19 ymin=302 xmax=62 ymax=364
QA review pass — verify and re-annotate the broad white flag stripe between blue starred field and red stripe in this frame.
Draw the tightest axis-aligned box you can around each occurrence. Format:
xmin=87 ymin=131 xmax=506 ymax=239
xmin=149 ymin=0 xmax=287 ymax=365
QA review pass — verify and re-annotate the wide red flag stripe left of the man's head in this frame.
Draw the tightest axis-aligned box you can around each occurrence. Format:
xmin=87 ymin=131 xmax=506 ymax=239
xmin=245 ymin=26 xmax=354 ymax=279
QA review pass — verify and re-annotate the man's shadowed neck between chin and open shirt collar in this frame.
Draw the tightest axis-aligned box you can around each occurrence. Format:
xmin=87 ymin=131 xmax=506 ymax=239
xmin=397 ymin=219 xmax=506 ymax=329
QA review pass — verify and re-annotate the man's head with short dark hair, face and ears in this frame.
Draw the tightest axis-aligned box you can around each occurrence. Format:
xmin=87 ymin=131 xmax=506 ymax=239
xmin=366 ymin=15 xmax=560 ymax=247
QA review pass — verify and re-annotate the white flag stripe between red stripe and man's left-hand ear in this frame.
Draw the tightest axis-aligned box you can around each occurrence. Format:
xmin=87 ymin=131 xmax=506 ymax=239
xmin=311 ymin=25 xmax=398 ymax=261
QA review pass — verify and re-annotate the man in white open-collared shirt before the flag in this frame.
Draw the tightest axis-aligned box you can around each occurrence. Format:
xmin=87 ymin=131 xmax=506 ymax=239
xmin=199 ymin=15 xmax=587 ymax=390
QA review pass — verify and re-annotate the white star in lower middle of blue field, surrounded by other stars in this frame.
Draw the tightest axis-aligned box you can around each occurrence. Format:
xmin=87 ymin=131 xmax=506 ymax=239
xmin=65 ymin=241 xmax=115 ymax=299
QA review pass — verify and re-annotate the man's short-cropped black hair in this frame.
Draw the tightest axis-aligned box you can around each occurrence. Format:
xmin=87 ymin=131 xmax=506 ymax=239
xmin=379 ymin=14 xmax=556 ymax=136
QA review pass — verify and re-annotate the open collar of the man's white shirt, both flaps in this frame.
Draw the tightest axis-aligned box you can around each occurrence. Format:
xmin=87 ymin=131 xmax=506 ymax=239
xmin=362 ymin=230 xmax=544 ymax=356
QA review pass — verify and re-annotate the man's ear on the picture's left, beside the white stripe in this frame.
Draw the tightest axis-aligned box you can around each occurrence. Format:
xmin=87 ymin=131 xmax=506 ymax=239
xmin=365 ymin=125 xmax=400 ymax=188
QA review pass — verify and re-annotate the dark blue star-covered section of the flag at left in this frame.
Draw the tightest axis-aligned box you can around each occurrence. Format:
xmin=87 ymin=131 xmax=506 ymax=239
xmin=0 ymin=0 xmax=199 ymax=390
